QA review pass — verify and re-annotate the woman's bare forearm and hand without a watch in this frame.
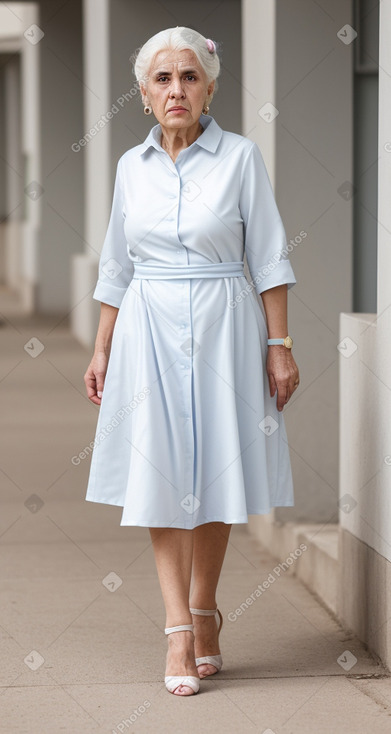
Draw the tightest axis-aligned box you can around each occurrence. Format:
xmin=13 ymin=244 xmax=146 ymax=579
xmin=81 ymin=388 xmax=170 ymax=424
xmin=84 ymin=302 xmax=118 ymax=405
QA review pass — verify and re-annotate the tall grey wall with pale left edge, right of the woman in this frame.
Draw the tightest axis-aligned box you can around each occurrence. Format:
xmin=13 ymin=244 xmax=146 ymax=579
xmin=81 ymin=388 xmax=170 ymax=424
xmin=243 ymin=0 xmax=353 ymax=532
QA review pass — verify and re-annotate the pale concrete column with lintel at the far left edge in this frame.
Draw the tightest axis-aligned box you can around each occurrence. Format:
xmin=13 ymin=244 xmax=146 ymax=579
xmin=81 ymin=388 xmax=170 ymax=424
xmin=0 ymin=3 xmax=42 ymax=311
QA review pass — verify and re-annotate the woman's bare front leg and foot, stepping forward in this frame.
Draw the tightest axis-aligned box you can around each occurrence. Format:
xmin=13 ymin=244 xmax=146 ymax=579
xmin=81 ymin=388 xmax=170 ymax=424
xmin=149 ymin=528 xmax=198 ymax=696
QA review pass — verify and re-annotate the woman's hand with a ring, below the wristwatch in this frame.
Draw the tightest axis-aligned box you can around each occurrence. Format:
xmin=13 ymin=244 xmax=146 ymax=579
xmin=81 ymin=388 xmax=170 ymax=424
xmin=266 ymin=344 xmax=299 ymax=410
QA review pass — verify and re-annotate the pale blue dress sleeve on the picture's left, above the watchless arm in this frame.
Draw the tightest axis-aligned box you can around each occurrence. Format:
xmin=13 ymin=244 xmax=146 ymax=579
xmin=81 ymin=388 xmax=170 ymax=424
xmin=93 ymin=158 xmax=134 ymax=308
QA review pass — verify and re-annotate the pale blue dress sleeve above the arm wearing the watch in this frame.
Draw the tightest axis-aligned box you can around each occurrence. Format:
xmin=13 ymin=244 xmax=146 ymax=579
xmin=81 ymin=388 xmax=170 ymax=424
xmin=239 ymin=143 xmax=296 ymax=294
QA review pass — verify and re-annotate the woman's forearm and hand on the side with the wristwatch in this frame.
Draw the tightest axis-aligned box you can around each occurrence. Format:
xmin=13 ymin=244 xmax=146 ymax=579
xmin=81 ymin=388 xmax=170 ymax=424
xmin=260 ymin=283 xmax=299 ymax=410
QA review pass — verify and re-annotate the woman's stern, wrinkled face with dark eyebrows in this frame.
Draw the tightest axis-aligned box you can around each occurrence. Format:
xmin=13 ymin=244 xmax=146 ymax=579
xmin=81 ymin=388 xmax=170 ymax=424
xmin=140 ymin=49 xmax=214 ymax=128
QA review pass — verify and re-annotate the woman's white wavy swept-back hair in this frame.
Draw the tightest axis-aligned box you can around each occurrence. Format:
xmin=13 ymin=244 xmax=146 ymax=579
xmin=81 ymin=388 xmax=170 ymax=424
xmin=130 ymin=26 xmax=220 ymax=102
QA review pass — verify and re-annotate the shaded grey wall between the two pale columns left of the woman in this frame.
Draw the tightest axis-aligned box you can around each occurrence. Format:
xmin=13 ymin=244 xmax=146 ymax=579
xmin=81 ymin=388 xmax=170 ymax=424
xmin=36 ymin=0 xmax=86 ymax=316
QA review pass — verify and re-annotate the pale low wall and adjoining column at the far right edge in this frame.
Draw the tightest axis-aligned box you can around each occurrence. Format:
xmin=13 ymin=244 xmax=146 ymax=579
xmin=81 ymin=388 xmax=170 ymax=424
xmin=337 ymin=3 xmax=391 ymax=669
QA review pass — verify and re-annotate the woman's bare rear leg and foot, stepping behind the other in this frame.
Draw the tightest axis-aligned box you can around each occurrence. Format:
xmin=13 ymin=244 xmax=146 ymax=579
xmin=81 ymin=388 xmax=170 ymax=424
xmin=189 ymin=522 xmax=232 ymax=678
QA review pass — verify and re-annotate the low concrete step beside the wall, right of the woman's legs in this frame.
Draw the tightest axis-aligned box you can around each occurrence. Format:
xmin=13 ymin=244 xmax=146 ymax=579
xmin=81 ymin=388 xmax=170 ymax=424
xmin=249 ymin=515 xmax=339 ymax=615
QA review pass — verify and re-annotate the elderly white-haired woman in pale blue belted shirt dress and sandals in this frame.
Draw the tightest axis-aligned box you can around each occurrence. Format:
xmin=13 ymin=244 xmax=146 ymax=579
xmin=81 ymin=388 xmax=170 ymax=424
xmin=84 ymin=27 xmax=299 ymax=695
